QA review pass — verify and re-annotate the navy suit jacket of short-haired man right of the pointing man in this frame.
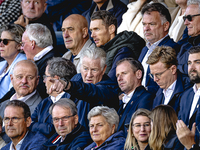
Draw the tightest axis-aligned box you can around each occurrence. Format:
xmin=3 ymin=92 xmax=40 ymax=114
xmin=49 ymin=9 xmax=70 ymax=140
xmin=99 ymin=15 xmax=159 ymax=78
xmin=117 ymin=86 xmax=155 ymax=135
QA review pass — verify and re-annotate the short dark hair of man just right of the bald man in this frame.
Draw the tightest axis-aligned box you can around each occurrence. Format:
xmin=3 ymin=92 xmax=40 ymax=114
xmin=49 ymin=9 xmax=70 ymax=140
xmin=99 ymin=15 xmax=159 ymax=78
xmin=91 ymin=10 xmax=118 ymax=34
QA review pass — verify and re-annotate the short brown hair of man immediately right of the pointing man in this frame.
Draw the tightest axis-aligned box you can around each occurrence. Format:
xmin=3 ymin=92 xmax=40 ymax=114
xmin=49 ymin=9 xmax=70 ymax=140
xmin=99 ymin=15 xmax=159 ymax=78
xmin=116 ymin=58 xmax=144 ymax=80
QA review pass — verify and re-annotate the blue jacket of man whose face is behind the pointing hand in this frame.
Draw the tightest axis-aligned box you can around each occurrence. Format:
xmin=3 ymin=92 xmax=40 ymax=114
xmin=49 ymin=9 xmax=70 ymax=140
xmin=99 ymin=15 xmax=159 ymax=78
xmin=29 ymin=93 xmax=69 ymax=138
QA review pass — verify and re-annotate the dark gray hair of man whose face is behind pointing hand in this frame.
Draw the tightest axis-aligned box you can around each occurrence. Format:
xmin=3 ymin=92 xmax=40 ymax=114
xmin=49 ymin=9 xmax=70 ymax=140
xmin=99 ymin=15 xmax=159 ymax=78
xmin=47 ymin=57 xmax=77 ymax=81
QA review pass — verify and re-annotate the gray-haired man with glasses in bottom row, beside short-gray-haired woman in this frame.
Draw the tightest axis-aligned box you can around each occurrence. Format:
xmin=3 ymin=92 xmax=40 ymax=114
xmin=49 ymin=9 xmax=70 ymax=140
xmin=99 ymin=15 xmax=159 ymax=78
xmin=44 ymin=98 xmax=92 ymax=150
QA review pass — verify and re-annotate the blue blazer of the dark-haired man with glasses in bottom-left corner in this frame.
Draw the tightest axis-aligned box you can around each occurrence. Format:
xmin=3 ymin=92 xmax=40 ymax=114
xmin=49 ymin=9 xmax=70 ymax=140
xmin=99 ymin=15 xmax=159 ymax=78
xmin=1 ymin=131 xmax=47 ymax=150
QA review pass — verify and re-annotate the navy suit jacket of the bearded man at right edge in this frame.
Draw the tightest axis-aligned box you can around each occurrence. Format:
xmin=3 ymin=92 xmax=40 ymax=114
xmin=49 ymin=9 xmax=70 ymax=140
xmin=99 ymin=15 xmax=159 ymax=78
xmin=178 ymin=87 xmax=200 ymax=128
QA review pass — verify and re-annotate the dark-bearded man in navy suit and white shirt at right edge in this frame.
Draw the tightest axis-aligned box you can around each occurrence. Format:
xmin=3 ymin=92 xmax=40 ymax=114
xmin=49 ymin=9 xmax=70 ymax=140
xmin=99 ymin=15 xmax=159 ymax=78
xmin=178 ymin=46 xmax=200 ymax=128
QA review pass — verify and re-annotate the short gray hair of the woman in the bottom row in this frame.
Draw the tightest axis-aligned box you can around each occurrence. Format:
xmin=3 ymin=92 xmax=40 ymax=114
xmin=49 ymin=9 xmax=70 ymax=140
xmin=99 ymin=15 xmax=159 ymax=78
xmin=87 ymin=106 xmax=119 ymax=132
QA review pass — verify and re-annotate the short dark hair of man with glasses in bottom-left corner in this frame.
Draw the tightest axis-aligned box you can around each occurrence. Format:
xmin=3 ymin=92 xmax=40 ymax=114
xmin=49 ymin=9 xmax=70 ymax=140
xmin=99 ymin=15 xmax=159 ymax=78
xmin=5 ymin=100 xmax=31 ymax=119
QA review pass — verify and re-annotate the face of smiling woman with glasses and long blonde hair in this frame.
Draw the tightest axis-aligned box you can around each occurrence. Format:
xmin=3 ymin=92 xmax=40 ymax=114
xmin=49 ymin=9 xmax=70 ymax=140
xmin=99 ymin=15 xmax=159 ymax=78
xmin=132 ymin=116 xmax=151 ymax=143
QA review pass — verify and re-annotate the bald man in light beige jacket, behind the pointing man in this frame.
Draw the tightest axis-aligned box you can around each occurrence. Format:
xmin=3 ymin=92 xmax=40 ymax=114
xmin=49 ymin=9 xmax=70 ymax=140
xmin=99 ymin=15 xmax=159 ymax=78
xmin=62 ymin=14 xmax=95 ymax=73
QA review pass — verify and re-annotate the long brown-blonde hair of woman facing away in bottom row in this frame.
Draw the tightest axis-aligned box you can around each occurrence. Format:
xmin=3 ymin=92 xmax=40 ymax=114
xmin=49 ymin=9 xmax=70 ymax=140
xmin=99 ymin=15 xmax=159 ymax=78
xmin=149 ymin=105 xmax=178 ymax=150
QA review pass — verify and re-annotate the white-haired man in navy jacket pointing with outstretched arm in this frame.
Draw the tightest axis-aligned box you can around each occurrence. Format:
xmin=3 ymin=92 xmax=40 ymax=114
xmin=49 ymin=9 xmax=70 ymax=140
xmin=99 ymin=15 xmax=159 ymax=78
xmin=48 ymin=47 xmax=119 ymax=128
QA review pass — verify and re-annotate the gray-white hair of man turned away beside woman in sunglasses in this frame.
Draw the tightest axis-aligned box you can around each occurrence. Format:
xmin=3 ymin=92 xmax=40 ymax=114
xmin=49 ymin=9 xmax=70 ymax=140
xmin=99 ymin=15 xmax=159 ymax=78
xmin=26 ymin=23 xmax=53 ymax=48
